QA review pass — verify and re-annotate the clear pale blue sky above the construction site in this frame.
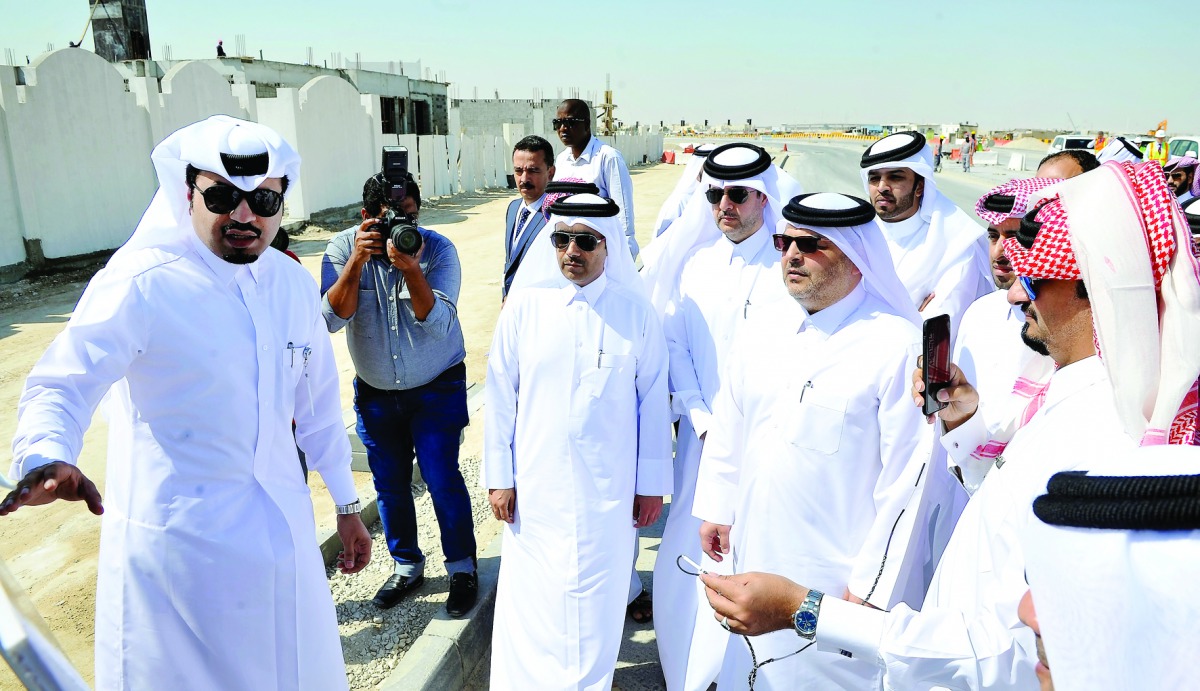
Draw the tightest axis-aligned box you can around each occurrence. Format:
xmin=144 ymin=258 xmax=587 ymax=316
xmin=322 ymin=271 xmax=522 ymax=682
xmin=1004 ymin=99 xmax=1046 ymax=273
xmin=0 ymin=0 xmax=1200 ymax=133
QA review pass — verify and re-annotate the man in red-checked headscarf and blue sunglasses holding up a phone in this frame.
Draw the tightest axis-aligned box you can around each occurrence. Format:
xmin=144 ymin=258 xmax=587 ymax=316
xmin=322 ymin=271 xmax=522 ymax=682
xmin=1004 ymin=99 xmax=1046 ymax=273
xmin=704 ymin=163 xmax=1200 ymax=689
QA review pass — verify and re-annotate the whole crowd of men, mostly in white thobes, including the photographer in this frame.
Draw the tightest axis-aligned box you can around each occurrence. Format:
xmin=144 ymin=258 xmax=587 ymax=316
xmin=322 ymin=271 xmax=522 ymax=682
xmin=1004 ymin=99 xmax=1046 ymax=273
xmin=0 ymin=107 xmax=1200 ymax=691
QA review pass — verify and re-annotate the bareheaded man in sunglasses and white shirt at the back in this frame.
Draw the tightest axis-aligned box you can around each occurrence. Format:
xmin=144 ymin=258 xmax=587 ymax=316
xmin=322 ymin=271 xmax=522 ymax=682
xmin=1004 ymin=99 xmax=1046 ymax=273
xmin=551 ymin=98 xmax=638 ymax=259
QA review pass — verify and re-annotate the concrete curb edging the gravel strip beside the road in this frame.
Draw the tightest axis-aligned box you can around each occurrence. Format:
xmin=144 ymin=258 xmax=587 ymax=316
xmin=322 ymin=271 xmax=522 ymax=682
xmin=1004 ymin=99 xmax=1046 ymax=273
xmin=379 ymin=533 xmax=504 ymax=691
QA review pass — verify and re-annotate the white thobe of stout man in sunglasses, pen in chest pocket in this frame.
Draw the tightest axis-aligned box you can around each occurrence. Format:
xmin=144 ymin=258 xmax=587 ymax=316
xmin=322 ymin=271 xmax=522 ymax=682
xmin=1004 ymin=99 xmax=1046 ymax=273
xmin=694 ymin=284 xmax=932 ymax=690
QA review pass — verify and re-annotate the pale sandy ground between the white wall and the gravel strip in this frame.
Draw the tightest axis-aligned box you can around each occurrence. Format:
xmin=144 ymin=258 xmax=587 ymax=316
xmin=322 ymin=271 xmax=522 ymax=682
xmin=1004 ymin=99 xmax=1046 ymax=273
xmin=0 ymin=166 xmax=683 ymax=689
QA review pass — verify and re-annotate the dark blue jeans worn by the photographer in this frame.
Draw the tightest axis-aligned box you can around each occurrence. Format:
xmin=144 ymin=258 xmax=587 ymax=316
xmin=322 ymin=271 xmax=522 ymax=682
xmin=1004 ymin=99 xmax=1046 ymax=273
xmin=354 ymin=365 xmax=475 ymax=573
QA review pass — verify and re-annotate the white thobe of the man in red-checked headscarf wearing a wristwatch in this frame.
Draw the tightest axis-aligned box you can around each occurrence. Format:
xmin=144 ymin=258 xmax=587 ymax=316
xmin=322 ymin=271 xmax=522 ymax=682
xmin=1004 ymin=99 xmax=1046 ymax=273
xmin=816 ymin=356 xmax=1135 ymax=689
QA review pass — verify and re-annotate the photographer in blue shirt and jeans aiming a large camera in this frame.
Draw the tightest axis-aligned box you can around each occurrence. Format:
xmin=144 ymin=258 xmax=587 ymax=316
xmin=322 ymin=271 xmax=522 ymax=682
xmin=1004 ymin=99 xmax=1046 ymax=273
xmin=322 ymin=172 xmax=478 ymax=617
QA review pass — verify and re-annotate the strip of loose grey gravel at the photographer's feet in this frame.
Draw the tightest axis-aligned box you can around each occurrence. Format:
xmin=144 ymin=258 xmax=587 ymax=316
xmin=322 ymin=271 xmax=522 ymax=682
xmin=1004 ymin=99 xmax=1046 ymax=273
xmin=328 ymin=456 xmax=494 ymax=690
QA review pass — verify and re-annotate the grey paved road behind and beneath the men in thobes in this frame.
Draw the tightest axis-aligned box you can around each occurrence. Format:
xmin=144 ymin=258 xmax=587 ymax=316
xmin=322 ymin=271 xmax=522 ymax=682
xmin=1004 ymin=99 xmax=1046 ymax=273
xmin=467 ymin=140 xmax=1008 ymax=691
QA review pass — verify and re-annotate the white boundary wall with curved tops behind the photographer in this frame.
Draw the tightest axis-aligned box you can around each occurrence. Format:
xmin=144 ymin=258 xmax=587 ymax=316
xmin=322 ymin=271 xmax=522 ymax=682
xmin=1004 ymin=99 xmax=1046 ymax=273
xmin=0 ymin=49 xmax=662 ymax=281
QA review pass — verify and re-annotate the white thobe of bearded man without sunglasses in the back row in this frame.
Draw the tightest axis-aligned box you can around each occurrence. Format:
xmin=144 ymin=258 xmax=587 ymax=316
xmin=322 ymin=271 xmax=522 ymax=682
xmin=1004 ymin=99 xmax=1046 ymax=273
xmin=878 ymin=211 xmax=995 ymax=335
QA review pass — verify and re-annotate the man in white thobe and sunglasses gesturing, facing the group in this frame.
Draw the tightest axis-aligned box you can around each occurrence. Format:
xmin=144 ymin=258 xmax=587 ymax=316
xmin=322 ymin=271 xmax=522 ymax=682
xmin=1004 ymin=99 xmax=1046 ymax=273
xmin=0 ymin=115 xmax=371 ymax=690
